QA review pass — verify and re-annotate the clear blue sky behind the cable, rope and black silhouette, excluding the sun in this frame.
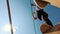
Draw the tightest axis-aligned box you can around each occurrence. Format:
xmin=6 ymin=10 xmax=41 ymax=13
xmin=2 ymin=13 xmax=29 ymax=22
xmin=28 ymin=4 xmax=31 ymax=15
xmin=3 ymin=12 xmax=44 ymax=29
xmin=0 ymin=0 xmax=60 ymax=34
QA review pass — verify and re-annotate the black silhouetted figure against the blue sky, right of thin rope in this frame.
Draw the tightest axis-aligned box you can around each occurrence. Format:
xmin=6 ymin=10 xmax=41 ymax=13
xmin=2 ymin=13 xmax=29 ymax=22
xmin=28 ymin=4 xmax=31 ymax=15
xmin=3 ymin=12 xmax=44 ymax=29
xmin=33 ymin=9 xmax=53 ymax=27
